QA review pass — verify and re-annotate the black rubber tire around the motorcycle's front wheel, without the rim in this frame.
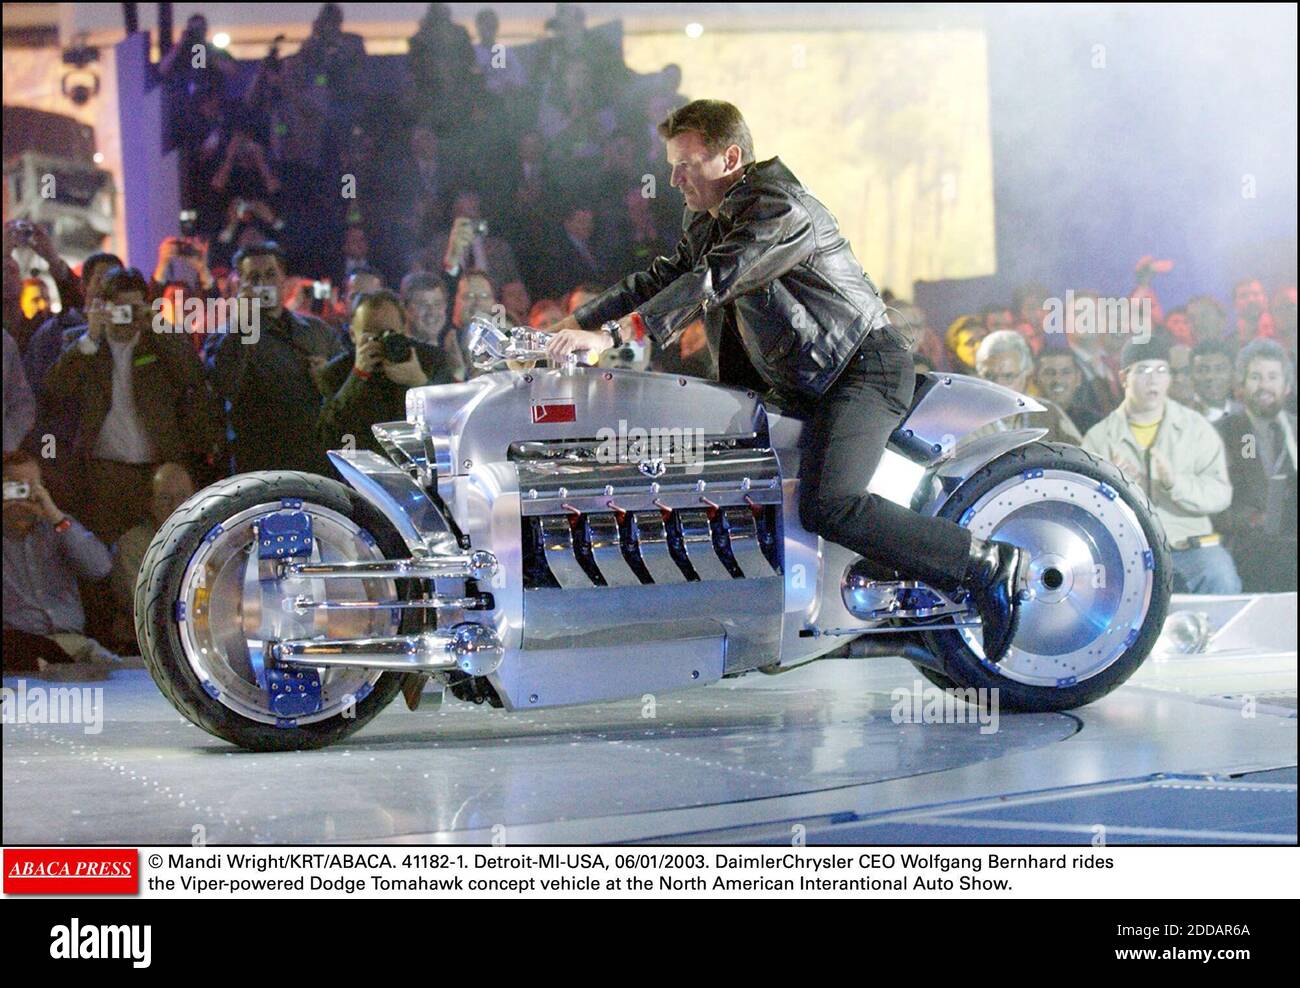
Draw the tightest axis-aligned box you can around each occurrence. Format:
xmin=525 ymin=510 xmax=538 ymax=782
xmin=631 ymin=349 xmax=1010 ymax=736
xmin=135 ymin=471 xmax=407 ymax=751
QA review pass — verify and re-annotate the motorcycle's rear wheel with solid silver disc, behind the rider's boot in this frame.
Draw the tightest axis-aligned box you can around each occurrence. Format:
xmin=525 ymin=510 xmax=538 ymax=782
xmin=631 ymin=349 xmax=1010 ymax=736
xmin=922 ymin=442 xmax=1173 ymax=711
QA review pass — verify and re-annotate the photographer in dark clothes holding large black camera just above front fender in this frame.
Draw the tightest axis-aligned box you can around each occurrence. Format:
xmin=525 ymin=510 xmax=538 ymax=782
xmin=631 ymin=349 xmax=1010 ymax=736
xmin=317 ymin=290 xmax=452 ymax=452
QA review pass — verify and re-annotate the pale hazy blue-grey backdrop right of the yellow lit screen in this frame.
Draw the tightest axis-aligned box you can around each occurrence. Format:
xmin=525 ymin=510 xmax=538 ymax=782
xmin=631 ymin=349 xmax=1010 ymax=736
xmin=917 ymin=4 xmax=1296 ymax=329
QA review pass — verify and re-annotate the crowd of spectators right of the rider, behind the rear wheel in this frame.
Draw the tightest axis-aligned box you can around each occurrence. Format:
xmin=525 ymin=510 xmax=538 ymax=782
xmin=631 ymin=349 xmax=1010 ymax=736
xmin=891 ymin=266 xmax=1296 ymax=594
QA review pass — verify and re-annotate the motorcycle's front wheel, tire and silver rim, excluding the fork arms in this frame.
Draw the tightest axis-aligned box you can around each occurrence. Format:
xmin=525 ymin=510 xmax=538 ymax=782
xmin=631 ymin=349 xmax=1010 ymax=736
xmin=135 ymin=471 xmax=406 ymax=751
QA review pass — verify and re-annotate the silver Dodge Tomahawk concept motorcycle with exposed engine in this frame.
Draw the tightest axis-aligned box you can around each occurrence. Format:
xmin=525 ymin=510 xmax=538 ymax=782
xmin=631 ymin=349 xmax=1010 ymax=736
xmin=135 ymin=320 xmax=1171 ymax=751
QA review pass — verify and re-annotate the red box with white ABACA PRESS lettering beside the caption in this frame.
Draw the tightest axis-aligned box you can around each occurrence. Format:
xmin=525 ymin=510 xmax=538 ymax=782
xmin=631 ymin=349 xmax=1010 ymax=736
xmin=4 ymin=848 xmax=140 ymax=896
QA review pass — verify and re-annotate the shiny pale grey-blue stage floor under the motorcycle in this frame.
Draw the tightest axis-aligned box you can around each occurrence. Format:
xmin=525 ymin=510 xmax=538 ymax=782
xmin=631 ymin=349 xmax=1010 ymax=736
xmin=3 ymin=598 xmax=1296 ymax=845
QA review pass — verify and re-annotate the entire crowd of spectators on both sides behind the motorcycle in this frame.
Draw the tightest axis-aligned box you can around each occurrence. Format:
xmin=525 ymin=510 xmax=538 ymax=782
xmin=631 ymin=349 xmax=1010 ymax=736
xmin=3 ymin=4 xmax=1296 ymax=668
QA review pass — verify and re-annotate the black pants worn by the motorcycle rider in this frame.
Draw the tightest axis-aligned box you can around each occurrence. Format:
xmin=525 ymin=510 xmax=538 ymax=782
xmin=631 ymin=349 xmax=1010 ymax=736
xmin=800 ymin=330 xmax=971 ymax=592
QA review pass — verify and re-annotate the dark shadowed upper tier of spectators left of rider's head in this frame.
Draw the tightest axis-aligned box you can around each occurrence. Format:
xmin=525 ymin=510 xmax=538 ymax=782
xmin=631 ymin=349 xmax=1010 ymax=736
xmin=159 ymin=4 xmax=685 ymax=302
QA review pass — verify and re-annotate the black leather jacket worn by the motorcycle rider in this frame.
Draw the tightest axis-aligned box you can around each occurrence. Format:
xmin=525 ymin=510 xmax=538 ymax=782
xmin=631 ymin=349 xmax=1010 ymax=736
xmin=573 ymin=157 xmax=888 ymax=398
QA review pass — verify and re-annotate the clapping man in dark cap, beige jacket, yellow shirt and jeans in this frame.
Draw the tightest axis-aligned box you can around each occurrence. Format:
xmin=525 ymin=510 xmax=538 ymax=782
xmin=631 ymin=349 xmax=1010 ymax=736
xmin=1083 ymin=335 xmax=1242 ymax=594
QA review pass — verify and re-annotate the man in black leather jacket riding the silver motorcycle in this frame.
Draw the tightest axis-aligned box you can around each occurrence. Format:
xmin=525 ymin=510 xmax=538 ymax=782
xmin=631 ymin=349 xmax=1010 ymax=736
xmin=549 ymin=100 xmax=1028 ymax=663
